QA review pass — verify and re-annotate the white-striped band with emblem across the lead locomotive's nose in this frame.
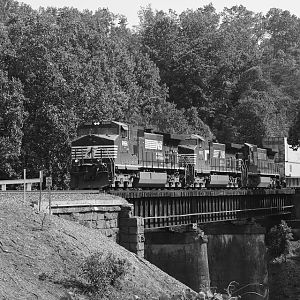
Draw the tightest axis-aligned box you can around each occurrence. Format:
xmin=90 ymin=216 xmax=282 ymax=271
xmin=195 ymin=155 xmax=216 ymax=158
xmin=72 ymin=145 xmax=118 ymax=160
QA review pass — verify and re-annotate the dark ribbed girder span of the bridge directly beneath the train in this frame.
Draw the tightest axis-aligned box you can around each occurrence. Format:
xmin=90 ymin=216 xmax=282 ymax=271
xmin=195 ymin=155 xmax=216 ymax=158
xmin=110 ymin=189 xmax=295 ymax=229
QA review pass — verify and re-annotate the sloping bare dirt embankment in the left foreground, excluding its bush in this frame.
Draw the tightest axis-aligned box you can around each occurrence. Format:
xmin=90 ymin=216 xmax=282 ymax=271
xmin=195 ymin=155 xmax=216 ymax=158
xmin=0 ymin=199 xmax=186 ymax=300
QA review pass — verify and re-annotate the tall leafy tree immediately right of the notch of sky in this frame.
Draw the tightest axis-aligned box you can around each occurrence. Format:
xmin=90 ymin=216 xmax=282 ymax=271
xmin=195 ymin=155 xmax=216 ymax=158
xmin=139 ymin=5 xmax=219 ymax=116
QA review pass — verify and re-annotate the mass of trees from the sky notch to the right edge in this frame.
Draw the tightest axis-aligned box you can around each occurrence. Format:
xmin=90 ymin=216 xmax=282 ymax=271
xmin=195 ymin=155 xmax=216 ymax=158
xmin=139 ymin=5 xmax=300 ymax=144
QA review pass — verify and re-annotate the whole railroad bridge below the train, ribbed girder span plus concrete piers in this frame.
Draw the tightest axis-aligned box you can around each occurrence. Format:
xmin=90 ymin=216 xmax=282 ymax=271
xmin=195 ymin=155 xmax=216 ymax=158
xmin=112 ymin=189 xmax=295 ymax=300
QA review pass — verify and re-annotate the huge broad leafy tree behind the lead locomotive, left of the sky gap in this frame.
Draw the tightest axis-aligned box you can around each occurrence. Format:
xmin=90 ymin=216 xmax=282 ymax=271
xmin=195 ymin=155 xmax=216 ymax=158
xmin=0 ymin=5 xmax=176 ymax=187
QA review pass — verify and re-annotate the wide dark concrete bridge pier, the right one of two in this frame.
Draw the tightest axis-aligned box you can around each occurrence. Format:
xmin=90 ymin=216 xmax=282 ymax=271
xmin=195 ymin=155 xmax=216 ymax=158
xmin=203 ymin=223 xmax=268 ymax=300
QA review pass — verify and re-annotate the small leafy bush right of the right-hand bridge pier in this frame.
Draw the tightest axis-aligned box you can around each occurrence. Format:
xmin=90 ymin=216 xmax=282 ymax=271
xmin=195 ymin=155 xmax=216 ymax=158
xmin=266 ymin=221 xmax=293 ymax=259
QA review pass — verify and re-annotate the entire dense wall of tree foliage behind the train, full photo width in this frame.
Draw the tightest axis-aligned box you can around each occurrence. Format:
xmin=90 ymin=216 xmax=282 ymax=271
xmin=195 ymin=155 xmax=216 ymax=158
xmin=0 ymin=0 xmax=300 ymax=187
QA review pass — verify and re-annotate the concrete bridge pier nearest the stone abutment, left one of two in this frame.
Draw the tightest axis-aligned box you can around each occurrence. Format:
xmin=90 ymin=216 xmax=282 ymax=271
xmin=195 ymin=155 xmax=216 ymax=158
xmin=145 ymin=228 xmax=210 ymax=291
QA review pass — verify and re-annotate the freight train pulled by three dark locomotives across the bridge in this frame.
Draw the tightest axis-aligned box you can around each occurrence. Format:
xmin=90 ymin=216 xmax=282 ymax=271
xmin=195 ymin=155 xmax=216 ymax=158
xmin=71 ymin=121 xmax=300 ymax=189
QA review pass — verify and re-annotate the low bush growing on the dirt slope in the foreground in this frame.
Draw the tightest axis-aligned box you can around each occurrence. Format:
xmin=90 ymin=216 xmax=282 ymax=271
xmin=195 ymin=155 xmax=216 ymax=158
xmin=82 ymin=252 xmax=129 ymax=296
